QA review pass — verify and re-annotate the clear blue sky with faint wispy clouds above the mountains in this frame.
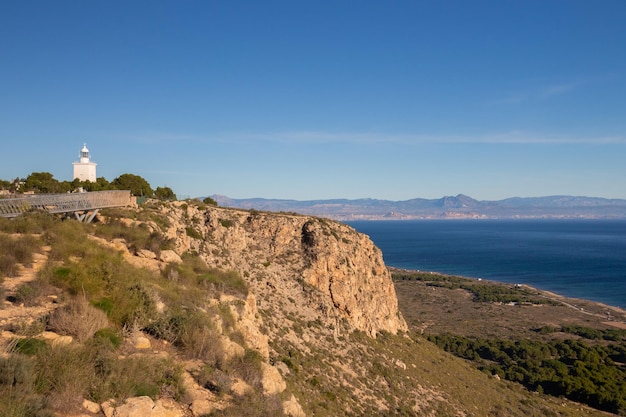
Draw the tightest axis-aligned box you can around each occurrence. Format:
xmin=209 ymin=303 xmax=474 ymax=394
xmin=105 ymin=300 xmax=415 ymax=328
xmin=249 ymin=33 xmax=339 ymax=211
xmin=0 ymin=0 xmax=626 ymax=200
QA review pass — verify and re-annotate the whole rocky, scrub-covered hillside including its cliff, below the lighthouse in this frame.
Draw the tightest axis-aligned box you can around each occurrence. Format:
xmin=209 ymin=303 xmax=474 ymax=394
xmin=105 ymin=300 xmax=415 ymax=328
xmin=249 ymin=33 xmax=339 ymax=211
xmin=0 ymin=202 xmax=616 ymax=416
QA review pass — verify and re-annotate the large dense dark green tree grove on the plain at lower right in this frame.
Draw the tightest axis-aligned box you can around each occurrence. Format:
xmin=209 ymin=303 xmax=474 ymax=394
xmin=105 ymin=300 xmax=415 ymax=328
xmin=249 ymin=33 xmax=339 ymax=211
xmin=429 ymin=335 xmax=626 ymax=415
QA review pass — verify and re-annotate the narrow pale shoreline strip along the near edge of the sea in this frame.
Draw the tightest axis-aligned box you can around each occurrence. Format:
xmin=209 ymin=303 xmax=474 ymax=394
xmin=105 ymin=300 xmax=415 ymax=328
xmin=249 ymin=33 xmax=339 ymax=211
xmin=387 ymin=266 xmax=626 ymax=324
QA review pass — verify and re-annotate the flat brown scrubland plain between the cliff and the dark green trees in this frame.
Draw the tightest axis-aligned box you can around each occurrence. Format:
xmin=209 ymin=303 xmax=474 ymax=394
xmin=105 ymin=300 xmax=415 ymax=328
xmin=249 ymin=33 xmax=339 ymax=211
xmin=391 ymin=269 xmax=626 ymax=339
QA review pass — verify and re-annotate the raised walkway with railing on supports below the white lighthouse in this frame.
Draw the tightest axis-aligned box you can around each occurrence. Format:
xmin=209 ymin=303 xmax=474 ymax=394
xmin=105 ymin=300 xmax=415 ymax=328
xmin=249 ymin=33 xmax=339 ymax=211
xmin=0 ymin=190 xmax=134 ymax=223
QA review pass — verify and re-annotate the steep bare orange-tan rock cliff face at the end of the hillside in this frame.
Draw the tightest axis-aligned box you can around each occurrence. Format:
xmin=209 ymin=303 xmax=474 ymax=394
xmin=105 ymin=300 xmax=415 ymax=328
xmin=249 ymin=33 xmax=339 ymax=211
xmin=158 ymin=203 xmax=407 ymax=337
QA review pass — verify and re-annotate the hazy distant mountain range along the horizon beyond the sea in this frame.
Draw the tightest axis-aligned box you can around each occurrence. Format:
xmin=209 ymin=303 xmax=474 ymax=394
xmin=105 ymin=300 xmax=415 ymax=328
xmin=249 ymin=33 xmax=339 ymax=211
xmin=211 ymin=194 xmax=626 ymax=221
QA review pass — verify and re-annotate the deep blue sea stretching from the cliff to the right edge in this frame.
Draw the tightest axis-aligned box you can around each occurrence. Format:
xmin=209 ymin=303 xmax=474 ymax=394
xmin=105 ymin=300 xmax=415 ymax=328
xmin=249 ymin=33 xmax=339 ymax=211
xmin=348 ymin=220 xmax=626 ymax=308
